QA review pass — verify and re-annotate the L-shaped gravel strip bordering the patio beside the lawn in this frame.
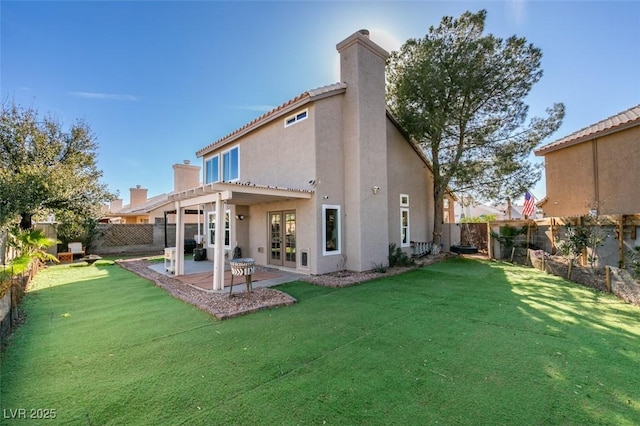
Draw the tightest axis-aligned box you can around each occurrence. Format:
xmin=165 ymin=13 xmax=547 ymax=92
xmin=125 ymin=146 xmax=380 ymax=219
xmin=117 ymin=259 xmax=296 ymax=320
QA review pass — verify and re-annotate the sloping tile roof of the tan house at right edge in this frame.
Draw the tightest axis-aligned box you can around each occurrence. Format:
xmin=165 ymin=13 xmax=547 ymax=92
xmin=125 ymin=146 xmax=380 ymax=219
xmin=535 ymin=105 xmax=640 ymax=155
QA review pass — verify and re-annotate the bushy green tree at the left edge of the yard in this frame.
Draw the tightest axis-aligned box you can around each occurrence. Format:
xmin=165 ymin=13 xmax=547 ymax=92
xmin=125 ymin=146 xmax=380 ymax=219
xmin=0 ymin=103 xmax=113 ymax=229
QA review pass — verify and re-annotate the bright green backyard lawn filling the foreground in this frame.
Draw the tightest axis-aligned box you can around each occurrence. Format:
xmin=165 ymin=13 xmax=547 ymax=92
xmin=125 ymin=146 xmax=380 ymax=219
xmin=0 ymin=259 xmax=640 ymax=425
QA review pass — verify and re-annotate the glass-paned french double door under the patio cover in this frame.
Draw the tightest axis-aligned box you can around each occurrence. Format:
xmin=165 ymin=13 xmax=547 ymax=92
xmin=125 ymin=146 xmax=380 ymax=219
xmin=269 ymin=210 xmax=296 ymax=268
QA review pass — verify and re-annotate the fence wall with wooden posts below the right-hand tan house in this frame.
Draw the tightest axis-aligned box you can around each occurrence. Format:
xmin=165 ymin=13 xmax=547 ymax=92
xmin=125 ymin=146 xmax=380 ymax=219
xmin=487 ymin=214 xmax=640 ymax=267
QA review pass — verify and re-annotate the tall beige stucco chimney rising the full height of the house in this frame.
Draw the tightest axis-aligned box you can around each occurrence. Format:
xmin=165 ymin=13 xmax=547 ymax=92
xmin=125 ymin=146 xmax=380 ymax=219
xmin=336 ymin=30 xmax=389 ymax=271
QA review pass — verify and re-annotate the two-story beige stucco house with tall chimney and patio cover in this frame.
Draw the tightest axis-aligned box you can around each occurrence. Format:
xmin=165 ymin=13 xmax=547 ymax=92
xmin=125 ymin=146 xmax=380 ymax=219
xmin=169 ymin=30 xmax=453 ymax=289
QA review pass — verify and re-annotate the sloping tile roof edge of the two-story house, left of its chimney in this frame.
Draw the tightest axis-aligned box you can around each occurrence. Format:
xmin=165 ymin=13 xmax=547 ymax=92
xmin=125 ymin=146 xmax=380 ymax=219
xmin=196 ymin=83 xmax=347 ymax=157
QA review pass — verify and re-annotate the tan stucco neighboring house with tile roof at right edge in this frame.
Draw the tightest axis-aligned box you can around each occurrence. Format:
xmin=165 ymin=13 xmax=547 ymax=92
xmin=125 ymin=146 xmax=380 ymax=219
xmin=535 ymin=105 xmax=640 ymax=217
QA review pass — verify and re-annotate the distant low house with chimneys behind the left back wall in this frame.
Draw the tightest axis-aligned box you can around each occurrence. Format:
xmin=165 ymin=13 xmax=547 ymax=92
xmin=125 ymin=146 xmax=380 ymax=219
xmin=100 ymin=160 xmax=202 ymax=226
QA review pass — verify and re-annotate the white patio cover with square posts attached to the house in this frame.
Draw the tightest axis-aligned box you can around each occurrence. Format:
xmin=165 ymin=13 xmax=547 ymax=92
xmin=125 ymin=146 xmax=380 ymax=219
xmin=169 ymin=182 xmax=313 ymax=290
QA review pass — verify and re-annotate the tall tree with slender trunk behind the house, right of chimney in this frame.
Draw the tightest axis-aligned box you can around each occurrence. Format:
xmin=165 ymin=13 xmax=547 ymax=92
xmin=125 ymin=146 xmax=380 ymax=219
xmin=387 ymin=10 xmax=564 ymax=242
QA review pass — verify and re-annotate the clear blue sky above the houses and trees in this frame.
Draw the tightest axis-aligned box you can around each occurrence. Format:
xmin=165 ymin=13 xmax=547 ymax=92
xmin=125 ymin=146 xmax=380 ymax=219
xmin=0 ymin=0 xmax=640 ymax=203
